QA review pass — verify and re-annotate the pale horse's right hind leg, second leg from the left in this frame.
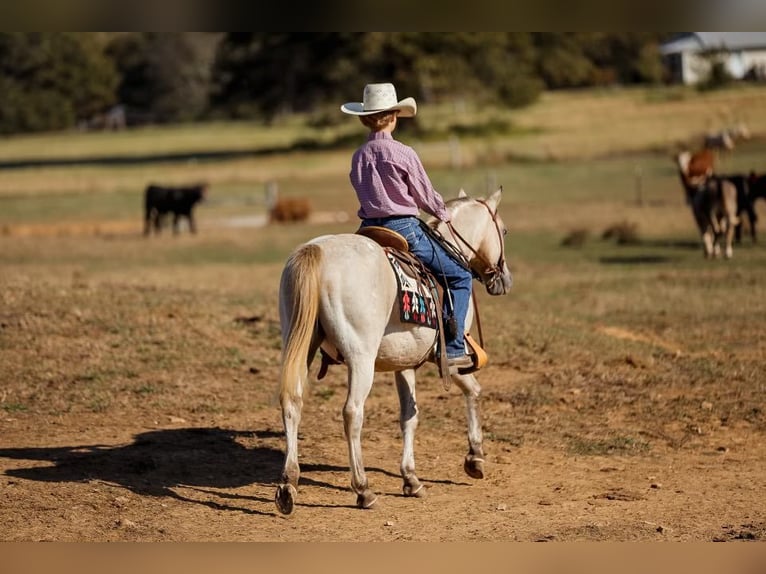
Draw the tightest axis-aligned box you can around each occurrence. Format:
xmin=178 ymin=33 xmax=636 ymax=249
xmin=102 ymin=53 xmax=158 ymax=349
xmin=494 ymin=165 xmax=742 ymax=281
xmin=343 ymin=358 xmax=378 ymax=508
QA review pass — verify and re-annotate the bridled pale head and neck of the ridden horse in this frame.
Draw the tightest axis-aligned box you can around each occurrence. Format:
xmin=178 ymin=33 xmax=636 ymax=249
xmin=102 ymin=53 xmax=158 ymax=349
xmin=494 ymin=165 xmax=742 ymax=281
xmin=438 ymin=187 xmax=513 ymax=295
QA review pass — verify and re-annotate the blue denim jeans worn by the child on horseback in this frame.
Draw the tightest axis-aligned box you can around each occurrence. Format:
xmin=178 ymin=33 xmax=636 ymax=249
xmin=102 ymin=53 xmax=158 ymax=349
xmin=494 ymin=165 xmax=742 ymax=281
xmin=362 ymin=216 xmax=473 ymax=359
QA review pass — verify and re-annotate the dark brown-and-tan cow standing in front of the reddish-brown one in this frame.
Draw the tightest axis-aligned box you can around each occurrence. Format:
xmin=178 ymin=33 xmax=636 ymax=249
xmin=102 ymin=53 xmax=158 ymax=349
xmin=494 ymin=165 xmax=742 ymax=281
xmin=677 ymin=152 xmax=739 ymax=259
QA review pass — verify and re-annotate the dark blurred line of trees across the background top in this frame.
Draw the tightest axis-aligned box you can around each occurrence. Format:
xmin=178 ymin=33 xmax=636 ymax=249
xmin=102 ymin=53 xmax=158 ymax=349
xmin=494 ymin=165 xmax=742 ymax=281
xmin=0 ymin=32 xmax=668 ymax=134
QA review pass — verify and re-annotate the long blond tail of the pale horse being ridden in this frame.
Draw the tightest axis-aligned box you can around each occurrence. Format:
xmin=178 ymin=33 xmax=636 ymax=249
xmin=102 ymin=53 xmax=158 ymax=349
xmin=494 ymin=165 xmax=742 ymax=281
xmin=280 ymin=244 xmax=322 ymax=404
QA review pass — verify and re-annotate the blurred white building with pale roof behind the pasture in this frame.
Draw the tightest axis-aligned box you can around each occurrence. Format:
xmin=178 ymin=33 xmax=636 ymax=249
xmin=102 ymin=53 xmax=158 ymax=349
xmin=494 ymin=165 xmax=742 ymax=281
xmin=660 ymin=32 xmax=766 ymax=84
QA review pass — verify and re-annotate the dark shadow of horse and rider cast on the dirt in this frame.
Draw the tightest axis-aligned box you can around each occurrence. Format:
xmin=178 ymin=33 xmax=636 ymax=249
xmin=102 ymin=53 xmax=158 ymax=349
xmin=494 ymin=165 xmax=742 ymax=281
xmin=0 ymin=427 xmax=452 ymax=515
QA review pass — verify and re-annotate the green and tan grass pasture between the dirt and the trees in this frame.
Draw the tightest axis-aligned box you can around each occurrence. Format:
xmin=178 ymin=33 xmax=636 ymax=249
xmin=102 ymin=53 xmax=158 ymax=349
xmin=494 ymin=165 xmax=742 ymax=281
xmin=0 ymin=83 xmax=766 ymax=420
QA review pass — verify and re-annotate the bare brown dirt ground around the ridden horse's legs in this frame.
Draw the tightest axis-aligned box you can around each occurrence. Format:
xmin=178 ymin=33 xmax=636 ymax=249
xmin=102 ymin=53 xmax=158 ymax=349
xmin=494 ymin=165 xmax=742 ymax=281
xmin=0 ymin=226 xmax=766 ymax=542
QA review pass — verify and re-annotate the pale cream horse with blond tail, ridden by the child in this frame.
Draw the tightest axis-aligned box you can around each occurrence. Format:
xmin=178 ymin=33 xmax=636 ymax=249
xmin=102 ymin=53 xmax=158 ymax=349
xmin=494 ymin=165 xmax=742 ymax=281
xmin=275 ymin=188 xmax=513 ymax=514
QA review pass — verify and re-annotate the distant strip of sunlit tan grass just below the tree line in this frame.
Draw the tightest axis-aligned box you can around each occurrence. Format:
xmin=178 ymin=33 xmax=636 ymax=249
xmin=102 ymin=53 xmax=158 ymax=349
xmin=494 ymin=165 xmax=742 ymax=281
xmin=0 ymin=87 xmax=766 ymax=202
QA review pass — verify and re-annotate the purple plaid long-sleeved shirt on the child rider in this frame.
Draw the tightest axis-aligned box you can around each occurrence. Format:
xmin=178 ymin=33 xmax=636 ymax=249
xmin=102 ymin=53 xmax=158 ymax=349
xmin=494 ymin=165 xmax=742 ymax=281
xmin=349 ymin=132 xmax=449 ymax=221
